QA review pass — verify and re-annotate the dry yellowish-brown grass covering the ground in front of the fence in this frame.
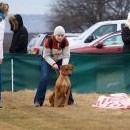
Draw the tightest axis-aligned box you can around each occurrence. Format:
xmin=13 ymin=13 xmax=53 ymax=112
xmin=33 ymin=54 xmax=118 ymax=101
xmin=0 ymin=90 xmax=130 ymax=130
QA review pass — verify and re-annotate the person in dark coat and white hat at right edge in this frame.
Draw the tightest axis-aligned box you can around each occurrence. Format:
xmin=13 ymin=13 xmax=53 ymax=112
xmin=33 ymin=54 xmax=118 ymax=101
xmin=121 ymin=12 xmax=130 ymax=52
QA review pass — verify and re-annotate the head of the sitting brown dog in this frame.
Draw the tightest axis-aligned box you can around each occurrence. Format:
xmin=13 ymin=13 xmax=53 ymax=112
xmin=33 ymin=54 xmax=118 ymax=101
xmin=60 ymin=64 xmax=74 ymax=75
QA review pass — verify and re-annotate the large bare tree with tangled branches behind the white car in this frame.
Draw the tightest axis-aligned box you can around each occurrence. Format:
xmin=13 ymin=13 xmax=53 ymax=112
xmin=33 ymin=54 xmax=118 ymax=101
xmin=50 ymin=0 xmax=130 ymax=32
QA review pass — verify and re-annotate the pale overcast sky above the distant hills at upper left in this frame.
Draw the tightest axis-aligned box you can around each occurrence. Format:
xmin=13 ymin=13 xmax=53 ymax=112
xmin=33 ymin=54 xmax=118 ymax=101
xmin=0 ymin=0 xmax=53 ymax=14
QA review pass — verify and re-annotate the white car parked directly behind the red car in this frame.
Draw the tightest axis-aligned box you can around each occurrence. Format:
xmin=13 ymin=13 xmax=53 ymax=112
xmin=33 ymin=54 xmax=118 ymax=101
xmin=69 ymin=20 xmax=126 ymax=48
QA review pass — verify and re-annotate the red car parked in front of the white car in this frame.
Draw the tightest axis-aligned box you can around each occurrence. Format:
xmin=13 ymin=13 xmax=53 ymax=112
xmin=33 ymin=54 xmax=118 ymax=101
xmin=71 ymin=31 xmax=123 ymax=53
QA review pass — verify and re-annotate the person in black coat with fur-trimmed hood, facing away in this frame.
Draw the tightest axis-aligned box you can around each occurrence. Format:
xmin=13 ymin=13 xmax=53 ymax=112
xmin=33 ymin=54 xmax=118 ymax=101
xmin=9 ymin=14 xmax=28 ymax=53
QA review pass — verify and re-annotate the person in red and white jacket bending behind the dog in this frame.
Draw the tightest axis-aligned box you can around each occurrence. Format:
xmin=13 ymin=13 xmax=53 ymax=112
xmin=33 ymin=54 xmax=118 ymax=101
xmin=34 ymin=26 xmax=74 ymax=107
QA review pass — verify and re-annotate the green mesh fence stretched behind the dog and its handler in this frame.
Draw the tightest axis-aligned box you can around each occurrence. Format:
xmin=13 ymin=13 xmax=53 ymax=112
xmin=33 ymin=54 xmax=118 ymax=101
xmin=2 ymin=53 xmax=130 ymax=93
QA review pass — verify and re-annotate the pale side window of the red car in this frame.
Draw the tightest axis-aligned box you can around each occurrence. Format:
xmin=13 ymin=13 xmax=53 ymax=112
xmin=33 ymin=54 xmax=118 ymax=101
xmin=104 ymin=34 xmax=123 ymax=46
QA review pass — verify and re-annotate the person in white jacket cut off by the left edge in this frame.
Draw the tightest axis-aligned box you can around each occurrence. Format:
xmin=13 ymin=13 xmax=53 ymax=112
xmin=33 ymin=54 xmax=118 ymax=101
xmin=0 ymin=2 xmax=9 ymax=108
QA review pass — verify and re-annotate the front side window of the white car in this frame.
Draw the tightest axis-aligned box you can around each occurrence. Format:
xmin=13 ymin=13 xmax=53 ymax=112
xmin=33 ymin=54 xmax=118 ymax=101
xmin=92 ymin=24 xmax=117 ymax=38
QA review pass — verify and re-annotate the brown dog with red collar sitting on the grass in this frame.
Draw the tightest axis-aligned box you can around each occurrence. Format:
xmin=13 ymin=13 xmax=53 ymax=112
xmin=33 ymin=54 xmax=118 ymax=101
xmin=49 ymin=64 xmax=73 ymax=107
